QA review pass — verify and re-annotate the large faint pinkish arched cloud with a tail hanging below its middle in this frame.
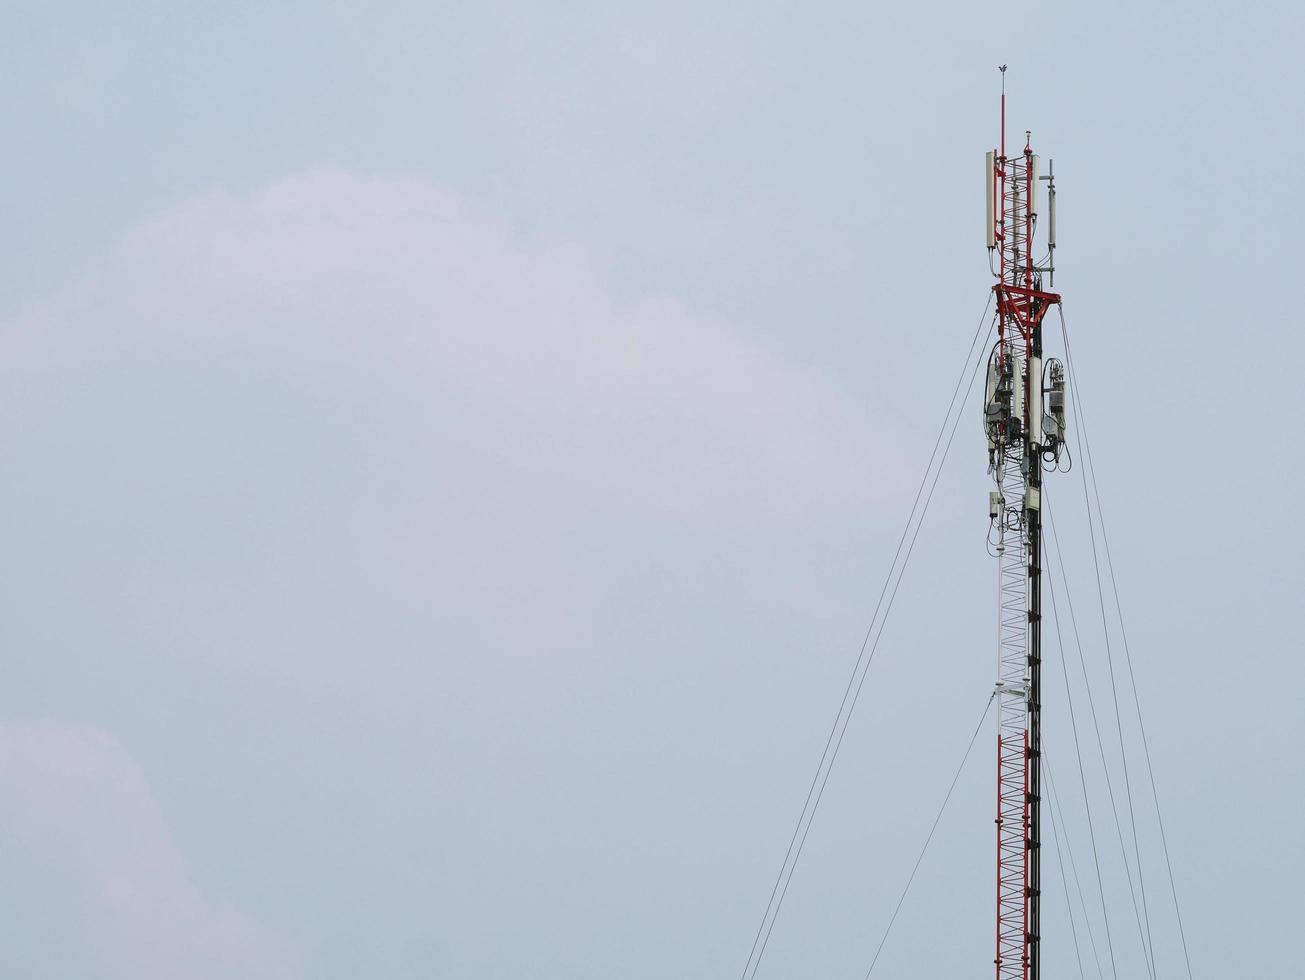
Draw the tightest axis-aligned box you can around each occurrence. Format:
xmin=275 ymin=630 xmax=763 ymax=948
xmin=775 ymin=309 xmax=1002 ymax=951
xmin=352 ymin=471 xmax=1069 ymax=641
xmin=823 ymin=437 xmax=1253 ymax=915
xmin=7 ymin=171 xmax=902 ymax=652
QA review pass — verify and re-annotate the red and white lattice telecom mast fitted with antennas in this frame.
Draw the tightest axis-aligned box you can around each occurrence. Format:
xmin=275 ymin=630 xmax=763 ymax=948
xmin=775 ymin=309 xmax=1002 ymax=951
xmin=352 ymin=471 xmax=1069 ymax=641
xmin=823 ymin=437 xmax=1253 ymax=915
xmin=984 ymin=65 xmax=1065 ymax=980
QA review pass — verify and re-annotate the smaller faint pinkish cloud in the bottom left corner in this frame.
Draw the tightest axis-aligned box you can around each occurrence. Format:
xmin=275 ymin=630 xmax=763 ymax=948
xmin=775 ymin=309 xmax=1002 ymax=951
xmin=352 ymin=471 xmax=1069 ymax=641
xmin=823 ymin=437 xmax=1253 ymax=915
xmin=0 ymin=722 xmax=295 ymax=980
